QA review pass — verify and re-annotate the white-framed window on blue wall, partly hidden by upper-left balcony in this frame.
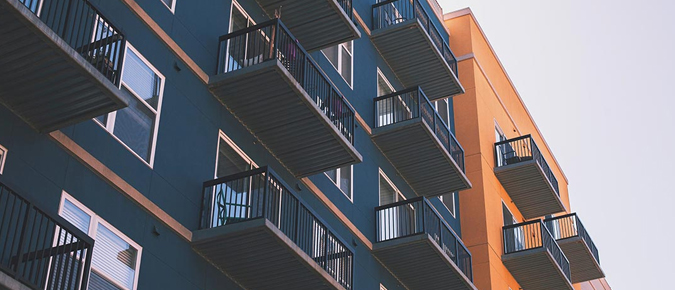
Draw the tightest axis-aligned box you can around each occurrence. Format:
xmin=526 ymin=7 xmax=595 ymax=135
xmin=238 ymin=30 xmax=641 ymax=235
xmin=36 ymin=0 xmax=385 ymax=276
xmin=95 ymin=43 xmax=164 ymax=167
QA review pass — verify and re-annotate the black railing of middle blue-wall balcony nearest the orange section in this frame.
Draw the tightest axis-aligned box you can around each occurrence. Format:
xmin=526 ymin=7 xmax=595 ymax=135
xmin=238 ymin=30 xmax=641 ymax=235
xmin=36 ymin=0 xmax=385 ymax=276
xmin=373 ymin=86 xmax=465 ymax=171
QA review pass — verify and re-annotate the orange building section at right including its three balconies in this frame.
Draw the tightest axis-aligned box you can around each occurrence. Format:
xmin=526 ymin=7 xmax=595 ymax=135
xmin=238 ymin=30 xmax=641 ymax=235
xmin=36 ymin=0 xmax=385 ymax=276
xmin=444 ymin=8 xmax=611 ymax=289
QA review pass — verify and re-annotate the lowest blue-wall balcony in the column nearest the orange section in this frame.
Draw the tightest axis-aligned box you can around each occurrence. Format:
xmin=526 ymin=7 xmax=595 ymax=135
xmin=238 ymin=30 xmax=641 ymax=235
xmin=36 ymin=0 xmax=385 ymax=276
xmin=373 ymin=197 xmax=476 ymax=290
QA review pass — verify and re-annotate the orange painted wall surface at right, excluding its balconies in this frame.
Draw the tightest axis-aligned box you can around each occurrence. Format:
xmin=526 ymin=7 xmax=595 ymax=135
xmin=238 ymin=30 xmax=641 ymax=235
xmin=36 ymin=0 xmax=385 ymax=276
xmin=444 ymin=8 xmax=611 ymax=290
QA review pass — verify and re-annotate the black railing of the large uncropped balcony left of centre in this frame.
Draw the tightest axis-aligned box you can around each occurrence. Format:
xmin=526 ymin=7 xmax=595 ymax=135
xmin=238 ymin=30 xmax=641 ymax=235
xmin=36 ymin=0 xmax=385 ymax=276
xmin=216 ymin=18 xmax=356 ymax=144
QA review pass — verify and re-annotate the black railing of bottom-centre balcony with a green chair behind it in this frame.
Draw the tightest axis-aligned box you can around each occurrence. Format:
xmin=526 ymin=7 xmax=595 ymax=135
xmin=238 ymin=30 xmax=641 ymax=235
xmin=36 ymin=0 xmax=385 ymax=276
xmin=201 ymin=167 xmax=354 ymax=289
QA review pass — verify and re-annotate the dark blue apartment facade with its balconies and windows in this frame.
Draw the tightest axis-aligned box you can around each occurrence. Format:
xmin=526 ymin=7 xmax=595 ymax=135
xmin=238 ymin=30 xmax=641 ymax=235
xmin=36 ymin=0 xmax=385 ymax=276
xmin=0 ymin=0 xmax=608 ymax=290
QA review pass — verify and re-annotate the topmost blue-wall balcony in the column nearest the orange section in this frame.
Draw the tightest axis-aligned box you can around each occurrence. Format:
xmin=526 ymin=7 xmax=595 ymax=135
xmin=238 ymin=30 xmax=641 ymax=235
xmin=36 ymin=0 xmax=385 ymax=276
xmin=370 ymin=0 xmax=464 ymax=101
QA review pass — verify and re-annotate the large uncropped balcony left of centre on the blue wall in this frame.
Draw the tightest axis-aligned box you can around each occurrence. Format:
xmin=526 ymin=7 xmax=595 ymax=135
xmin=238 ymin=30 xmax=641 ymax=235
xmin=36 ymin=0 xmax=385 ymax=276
xmin=209 ymin=20 xmax=363 ymax=177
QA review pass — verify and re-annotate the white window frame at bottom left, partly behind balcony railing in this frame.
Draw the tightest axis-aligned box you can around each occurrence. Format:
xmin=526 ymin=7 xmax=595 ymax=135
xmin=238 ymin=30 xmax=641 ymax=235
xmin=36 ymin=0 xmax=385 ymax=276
xmin=57 ymin=190 xmax=143 ymax=290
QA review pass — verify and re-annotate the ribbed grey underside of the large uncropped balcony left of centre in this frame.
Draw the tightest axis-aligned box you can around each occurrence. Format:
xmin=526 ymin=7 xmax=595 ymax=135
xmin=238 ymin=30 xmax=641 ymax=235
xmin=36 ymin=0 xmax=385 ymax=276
xmin=209 ymin=60 xmax=363 ymax=177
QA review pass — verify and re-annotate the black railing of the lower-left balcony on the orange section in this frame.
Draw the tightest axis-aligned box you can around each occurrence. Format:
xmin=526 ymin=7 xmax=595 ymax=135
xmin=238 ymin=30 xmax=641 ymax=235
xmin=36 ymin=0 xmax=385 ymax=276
xmin=503 ymin=220 xmax=571 ymax=280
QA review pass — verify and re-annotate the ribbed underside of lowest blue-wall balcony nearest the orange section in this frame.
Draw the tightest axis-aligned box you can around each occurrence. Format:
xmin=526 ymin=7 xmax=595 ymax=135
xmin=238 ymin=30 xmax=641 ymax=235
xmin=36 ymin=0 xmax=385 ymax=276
xmin=373 ymin=233 xmax=476 ymax=290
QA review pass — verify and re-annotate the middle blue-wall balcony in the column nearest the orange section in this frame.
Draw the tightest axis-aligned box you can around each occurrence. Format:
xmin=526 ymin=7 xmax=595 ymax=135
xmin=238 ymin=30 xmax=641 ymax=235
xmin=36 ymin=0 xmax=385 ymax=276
xmin=372 ymin=87 xmax=471 ymax=197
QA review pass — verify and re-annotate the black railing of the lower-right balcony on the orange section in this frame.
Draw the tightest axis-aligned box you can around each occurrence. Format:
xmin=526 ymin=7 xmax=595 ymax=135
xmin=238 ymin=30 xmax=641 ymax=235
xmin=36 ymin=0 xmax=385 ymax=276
xmin=544 ymin=213 xmax=600 ymax=264
